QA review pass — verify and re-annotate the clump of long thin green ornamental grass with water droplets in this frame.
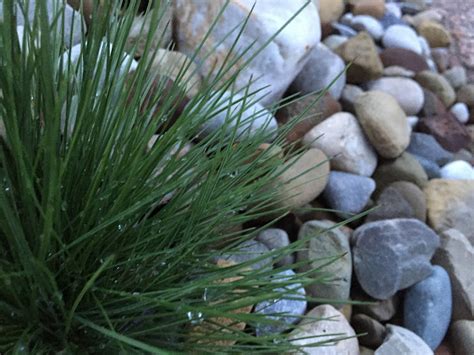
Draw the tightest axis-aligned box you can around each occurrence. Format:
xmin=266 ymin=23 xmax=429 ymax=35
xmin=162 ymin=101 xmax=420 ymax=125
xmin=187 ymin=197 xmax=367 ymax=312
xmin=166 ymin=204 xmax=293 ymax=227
xmin=0 ymin=0 xmax=348 ymax=354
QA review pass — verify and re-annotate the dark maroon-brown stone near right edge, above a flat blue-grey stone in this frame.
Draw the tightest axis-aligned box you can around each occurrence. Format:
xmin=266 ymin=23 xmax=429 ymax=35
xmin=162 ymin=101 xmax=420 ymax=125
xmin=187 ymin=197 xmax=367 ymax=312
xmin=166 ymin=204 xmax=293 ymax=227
xmin=418 ymin=112 xmax=471 ymax=152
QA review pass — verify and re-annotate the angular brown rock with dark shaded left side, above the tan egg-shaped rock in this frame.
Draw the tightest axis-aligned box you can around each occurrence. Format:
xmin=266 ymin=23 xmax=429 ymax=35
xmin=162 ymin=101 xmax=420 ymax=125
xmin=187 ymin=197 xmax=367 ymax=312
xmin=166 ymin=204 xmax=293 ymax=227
xmin=336 ymin=32 xmax=383 ymax=84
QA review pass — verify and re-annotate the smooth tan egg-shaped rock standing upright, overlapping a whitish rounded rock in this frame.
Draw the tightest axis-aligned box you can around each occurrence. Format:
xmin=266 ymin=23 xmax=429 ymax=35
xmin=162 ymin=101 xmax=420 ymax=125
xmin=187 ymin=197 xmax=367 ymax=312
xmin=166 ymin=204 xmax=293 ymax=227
xmin=355 ymin=91 xmax=410 ymax=159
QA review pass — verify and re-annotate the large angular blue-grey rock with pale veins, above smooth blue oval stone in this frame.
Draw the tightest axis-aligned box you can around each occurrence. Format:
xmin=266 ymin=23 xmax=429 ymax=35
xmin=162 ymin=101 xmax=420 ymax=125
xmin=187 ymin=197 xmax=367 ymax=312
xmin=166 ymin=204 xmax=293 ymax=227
xmin=352 ymin=219 xmax=439 ymax=299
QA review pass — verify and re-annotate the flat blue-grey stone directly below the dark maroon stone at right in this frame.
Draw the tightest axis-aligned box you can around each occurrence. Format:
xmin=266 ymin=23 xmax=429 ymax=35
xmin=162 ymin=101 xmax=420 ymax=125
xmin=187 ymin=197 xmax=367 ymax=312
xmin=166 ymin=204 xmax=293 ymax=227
xmin=407 ymin=132 xmax=453 ymax=166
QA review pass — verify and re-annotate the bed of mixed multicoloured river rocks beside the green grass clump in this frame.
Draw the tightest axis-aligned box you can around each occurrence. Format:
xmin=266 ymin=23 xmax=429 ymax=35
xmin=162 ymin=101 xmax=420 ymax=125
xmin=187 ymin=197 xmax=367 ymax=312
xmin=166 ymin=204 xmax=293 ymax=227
xmin=39 ymin=0 xmax=474 ymax=355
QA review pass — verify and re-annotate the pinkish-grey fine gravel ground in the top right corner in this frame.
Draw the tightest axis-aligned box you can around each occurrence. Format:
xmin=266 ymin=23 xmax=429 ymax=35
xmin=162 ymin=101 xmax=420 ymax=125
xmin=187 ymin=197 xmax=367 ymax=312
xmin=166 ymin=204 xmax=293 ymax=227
xmin=433 ymin=0 xmax=474 ymax=80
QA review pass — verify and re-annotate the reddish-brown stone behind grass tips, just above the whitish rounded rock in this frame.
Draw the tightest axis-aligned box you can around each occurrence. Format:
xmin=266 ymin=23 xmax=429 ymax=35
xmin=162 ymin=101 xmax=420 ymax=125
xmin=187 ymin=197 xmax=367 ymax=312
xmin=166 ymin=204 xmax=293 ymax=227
xmin=276 ymin=93 xmax=342 ymax=142
